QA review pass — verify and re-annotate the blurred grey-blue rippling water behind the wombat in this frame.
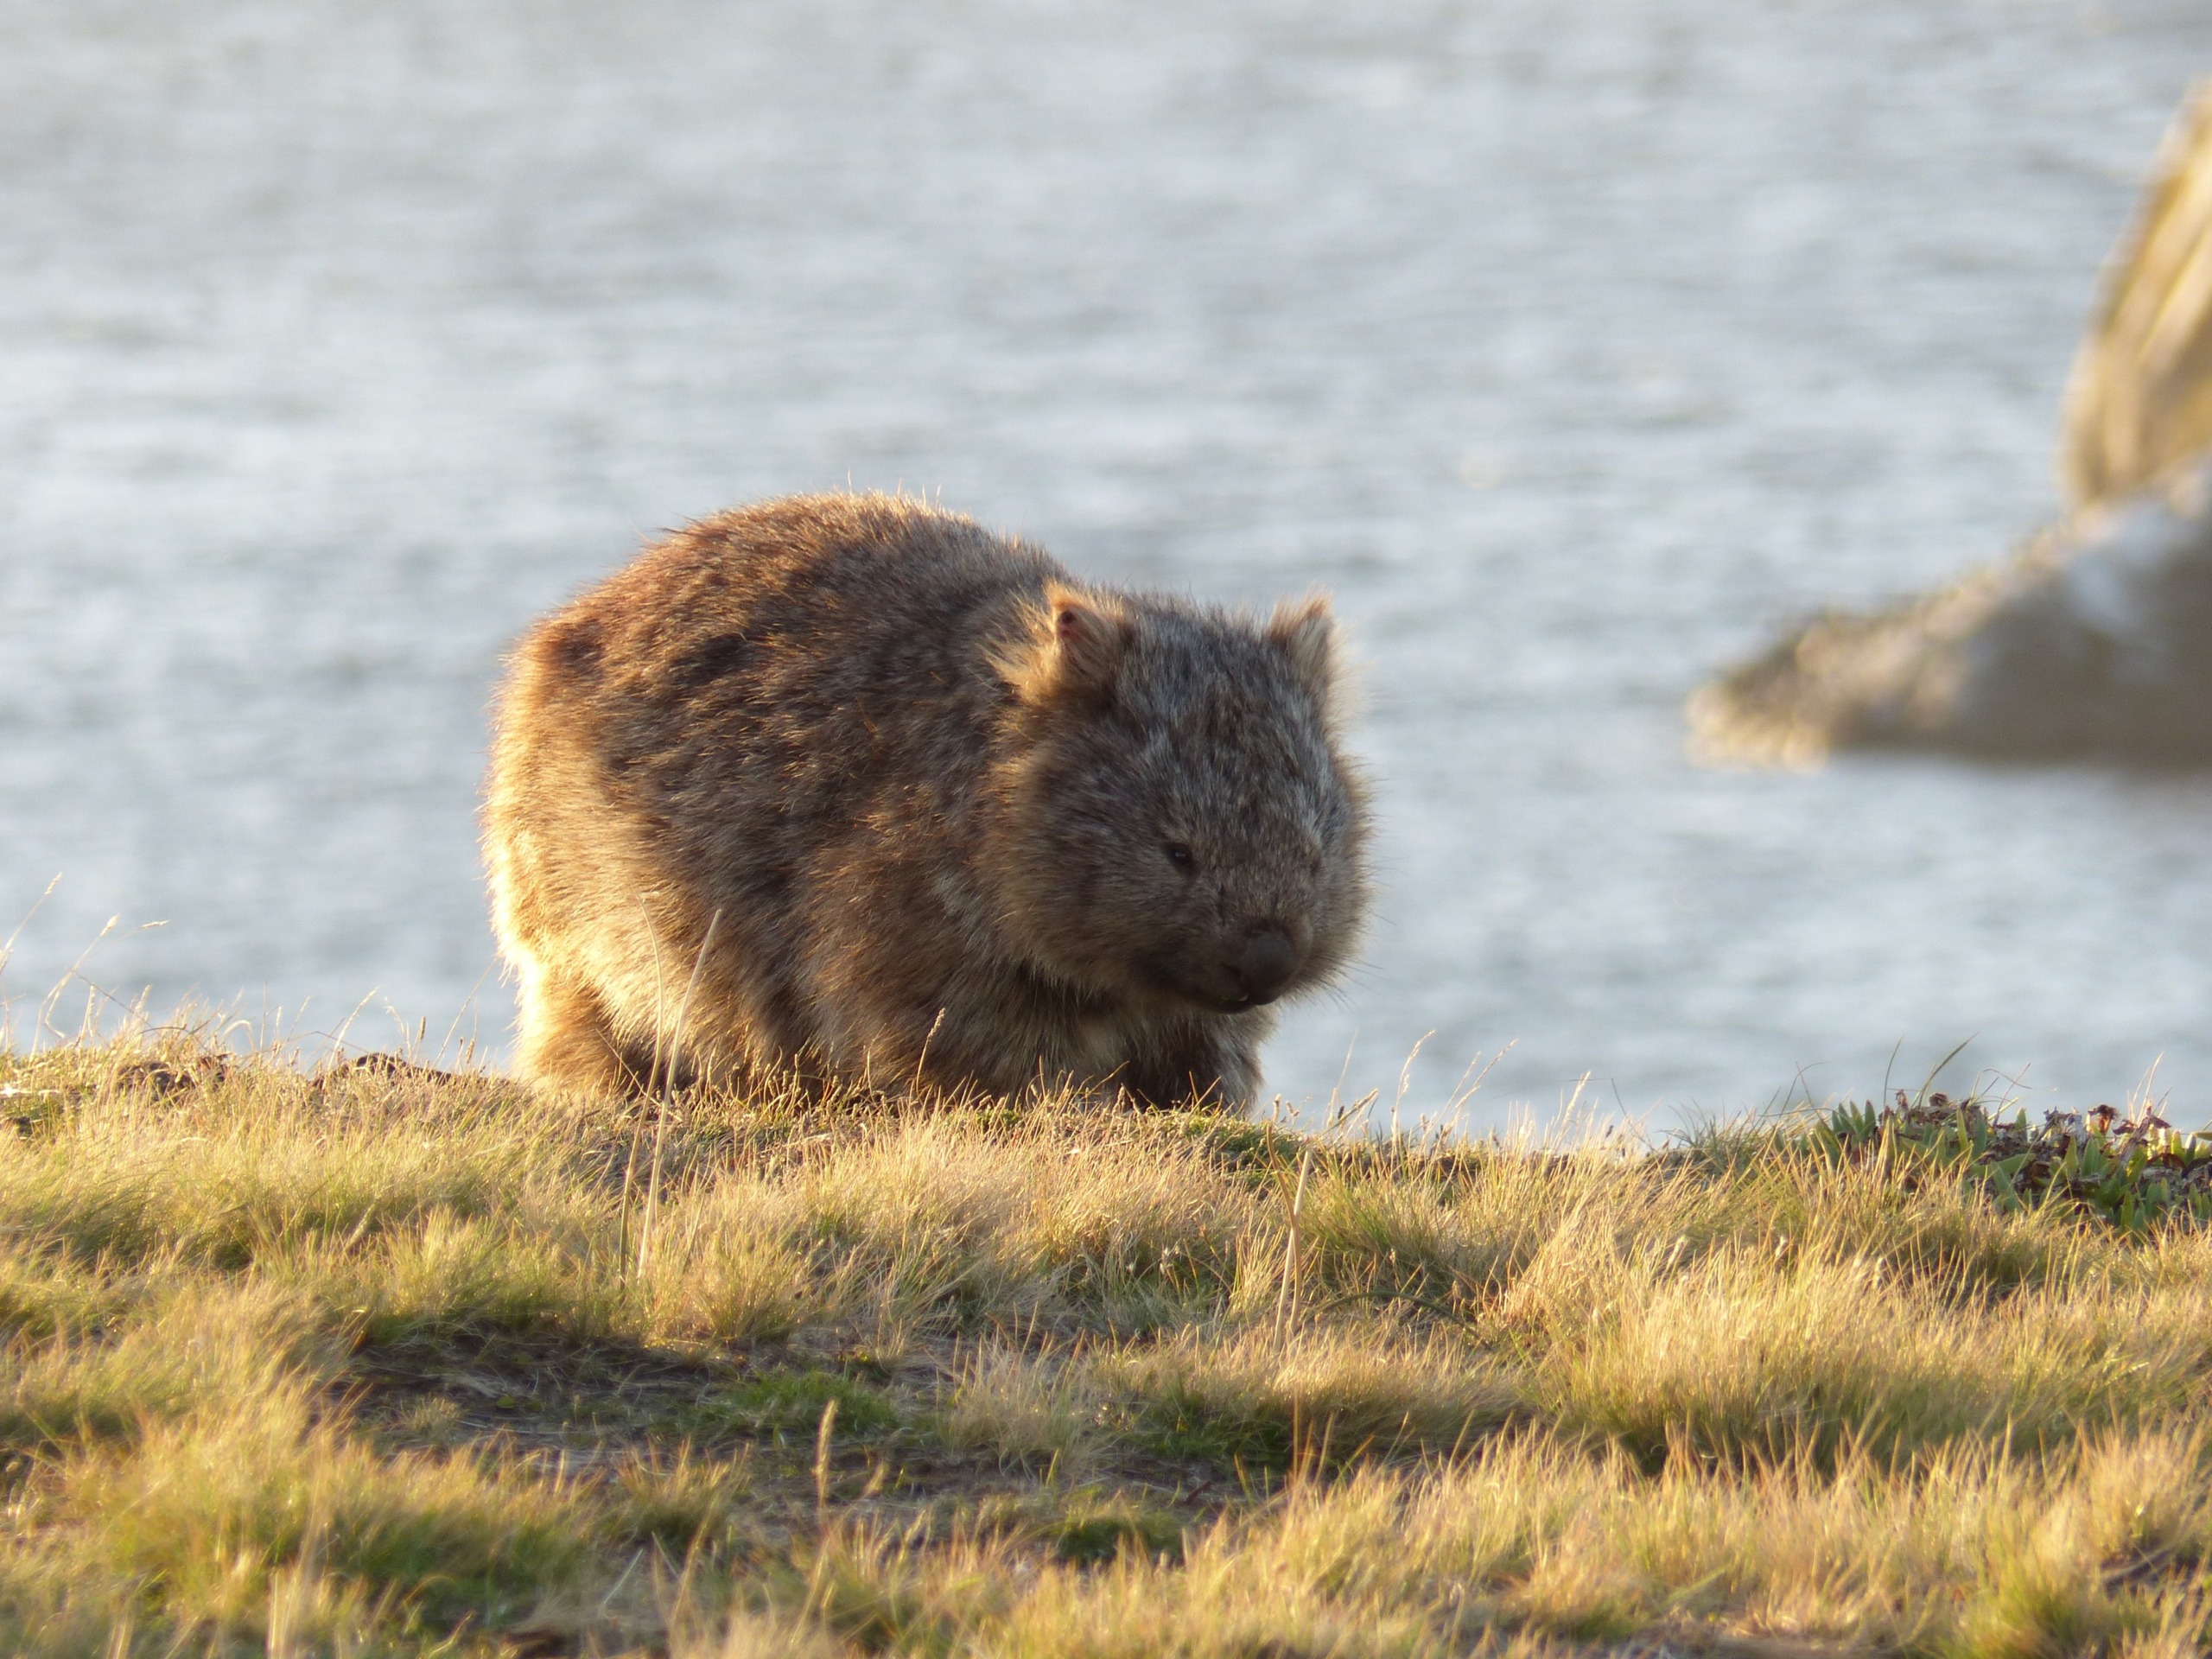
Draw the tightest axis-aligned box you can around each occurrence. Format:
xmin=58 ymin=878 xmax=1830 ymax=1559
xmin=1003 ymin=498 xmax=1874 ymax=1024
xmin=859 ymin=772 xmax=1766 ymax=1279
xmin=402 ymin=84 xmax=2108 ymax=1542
xmin=0 ymin=0 xmax=2212 ymax=1126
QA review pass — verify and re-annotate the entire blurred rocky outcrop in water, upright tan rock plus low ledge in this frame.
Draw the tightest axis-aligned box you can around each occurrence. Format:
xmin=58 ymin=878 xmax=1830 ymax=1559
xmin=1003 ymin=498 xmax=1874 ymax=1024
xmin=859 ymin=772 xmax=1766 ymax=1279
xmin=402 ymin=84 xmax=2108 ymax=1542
xmin=1688 ymin=82 xmax=2212 ymax=766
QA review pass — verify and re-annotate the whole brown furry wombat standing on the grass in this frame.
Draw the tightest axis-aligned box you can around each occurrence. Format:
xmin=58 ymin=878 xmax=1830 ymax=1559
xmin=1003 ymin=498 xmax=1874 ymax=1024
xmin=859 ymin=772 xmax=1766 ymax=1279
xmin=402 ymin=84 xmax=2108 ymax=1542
xmin=485 ymin=495 xmax=1367 ymax=1103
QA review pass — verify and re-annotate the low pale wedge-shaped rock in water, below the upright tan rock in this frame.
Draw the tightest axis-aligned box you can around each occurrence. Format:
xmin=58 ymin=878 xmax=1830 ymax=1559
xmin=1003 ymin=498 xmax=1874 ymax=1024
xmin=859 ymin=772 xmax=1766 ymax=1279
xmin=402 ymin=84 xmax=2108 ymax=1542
xmin=1690 ymin=465 xmax=2212 ymax=766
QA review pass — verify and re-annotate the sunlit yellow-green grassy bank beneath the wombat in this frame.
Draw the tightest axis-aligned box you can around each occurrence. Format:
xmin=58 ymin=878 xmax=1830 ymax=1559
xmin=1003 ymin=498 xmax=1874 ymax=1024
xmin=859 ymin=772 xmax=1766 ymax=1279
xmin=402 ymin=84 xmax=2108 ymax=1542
xmin=0 ymin=1038 xmax=2212 ymax=1656
